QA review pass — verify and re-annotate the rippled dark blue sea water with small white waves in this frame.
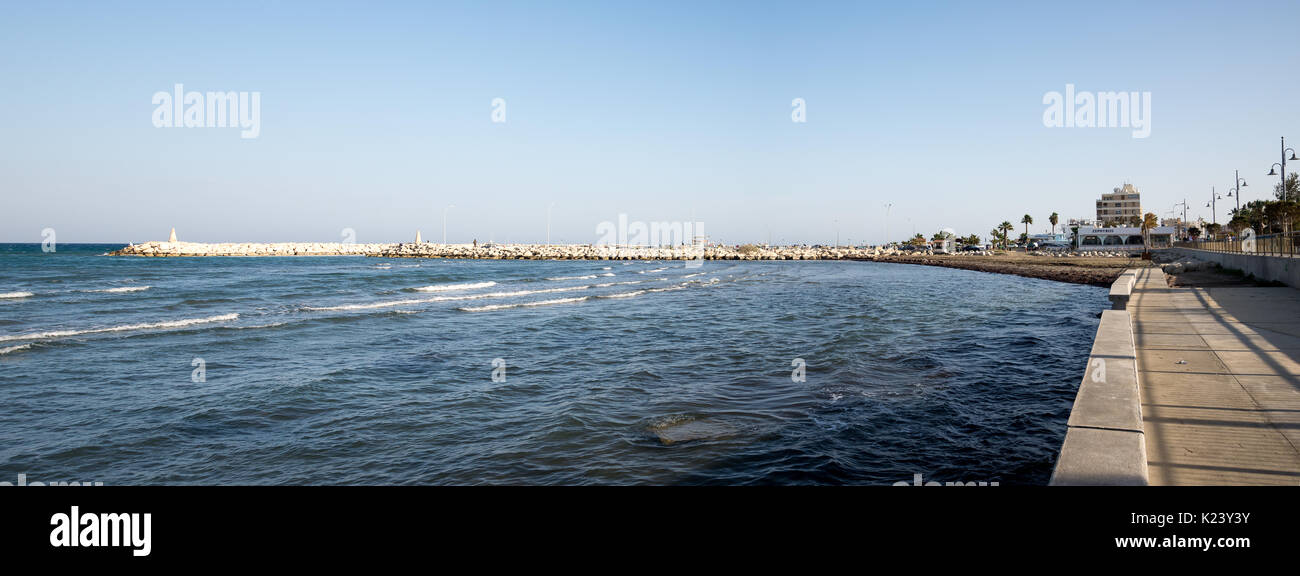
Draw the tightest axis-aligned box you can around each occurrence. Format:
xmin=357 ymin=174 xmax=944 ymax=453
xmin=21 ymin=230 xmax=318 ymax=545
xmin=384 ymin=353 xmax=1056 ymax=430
xmin=0 ymin=244 xmax=1108 ymax=485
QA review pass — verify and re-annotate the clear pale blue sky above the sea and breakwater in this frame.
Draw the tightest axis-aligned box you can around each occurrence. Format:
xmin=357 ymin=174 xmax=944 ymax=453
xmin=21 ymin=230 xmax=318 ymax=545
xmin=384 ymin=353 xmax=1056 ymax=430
xmin=0 ymin=0 xmax=1300 ymax=243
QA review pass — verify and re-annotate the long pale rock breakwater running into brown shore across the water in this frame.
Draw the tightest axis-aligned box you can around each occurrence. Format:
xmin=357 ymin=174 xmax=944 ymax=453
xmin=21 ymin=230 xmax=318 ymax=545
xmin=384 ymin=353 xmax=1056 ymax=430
xmin=109 ymin=242 xmax=1128 ymax=286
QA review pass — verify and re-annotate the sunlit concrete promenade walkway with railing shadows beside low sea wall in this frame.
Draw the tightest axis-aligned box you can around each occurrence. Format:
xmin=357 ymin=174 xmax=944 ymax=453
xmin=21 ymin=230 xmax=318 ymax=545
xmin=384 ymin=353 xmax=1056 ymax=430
xmin=1127 ymin=268 xmax=1300 ymax=486
